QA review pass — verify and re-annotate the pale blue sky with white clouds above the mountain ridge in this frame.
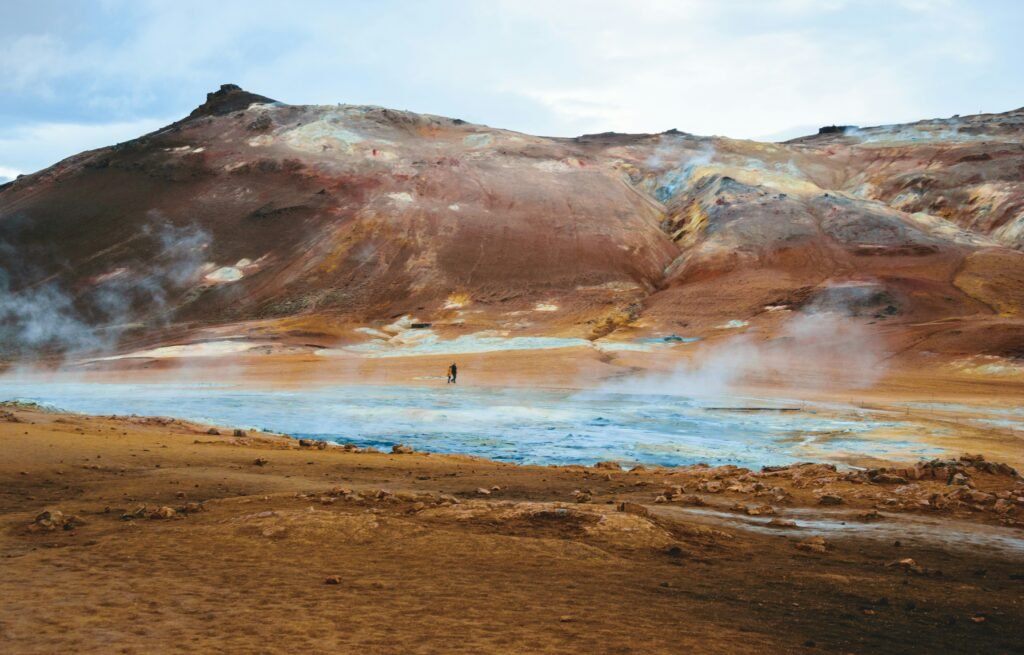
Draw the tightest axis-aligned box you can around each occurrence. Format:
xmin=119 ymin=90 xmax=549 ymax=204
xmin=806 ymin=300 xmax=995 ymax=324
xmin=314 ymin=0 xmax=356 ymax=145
xmin=0 ymin=0 xmax=1024 ymax=182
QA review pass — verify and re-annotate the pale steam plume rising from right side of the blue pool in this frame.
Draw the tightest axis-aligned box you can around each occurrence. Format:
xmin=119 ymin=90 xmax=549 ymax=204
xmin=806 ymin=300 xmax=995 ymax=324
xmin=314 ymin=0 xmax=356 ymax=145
xmin=603 ymin=310 xmax=886 ymax=398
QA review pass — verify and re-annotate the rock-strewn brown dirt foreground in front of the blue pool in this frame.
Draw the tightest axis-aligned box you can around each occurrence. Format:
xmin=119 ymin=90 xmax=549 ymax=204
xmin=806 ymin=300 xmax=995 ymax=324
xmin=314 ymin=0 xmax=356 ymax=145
xmin=0 ymin=405 xmax=1024 ymax=654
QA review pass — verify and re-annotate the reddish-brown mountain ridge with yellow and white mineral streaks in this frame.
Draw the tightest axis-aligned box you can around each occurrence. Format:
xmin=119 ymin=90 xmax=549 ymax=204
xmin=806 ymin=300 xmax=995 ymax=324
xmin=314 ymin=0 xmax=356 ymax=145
xmin=0 ymin=85 xmax=1024 ymax=368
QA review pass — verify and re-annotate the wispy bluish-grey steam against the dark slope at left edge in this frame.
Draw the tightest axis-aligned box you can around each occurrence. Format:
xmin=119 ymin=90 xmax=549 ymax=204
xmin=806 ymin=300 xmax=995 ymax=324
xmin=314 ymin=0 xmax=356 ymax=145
xmin=0 ymin=212 xmax=210 ymax=358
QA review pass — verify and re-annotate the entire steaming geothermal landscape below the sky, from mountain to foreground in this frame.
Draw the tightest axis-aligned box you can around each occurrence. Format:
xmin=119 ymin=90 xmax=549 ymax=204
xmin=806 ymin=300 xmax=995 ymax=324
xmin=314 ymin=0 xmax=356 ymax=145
xmin=0 ymin=85 xmax=1024 ymax=654
